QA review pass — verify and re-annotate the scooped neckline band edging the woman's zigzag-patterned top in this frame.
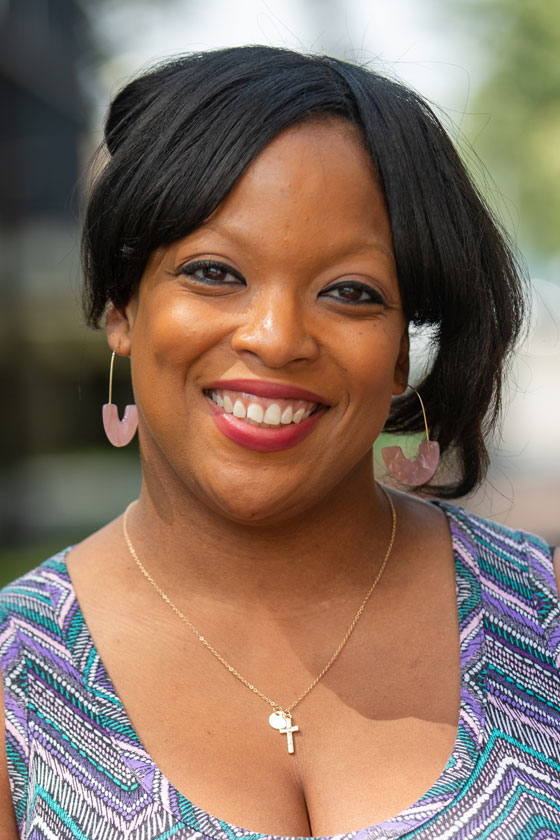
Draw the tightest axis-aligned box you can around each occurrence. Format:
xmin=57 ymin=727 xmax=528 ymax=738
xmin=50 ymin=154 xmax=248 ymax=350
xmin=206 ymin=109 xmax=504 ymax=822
xmin=53 ymin=502 xmax=485 ymax=840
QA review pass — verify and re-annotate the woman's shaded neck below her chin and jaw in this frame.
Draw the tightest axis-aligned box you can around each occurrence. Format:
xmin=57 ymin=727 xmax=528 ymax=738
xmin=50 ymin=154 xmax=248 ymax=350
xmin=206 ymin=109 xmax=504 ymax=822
xmin=128 ymin=459 xmax=391 ymax=610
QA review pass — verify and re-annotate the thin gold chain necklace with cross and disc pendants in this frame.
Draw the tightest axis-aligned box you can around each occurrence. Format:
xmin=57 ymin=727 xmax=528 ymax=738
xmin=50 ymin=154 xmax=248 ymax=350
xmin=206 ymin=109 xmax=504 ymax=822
xmin=123 ymin=484 xmax=397 ymax=754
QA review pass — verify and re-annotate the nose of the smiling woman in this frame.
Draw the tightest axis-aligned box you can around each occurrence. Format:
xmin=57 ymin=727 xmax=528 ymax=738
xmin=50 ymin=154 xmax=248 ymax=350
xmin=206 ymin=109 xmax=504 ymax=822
xmin=231 ymin=288 xmax=319 ymax=368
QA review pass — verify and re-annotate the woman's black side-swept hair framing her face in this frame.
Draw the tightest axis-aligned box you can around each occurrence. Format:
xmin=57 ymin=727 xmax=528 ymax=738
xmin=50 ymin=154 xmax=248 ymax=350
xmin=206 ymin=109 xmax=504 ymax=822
xmin=82 ymin=46 xmax=524 ymax=498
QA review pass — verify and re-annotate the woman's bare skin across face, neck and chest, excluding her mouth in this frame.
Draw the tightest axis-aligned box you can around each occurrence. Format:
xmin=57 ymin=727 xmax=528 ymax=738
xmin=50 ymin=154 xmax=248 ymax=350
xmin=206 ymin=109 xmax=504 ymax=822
xmin=0 ymin=119 xmax=556 ymax=837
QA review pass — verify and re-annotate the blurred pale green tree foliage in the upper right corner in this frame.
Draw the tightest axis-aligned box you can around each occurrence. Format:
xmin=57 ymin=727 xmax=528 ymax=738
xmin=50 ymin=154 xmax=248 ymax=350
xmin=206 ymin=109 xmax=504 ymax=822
xmin=445 ymin=0 xmax=560 ymax=266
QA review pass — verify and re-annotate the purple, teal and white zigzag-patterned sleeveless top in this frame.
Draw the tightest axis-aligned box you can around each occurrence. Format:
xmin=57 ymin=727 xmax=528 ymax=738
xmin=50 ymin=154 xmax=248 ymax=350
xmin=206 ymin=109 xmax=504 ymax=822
xmin=0 ymin=504 xmax=560 ymax=840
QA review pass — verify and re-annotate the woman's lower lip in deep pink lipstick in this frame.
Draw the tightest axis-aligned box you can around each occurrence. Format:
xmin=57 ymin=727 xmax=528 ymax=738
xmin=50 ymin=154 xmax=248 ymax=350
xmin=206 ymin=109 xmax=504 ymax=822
xmin=206 ymin=396 xmax=327 ymax=452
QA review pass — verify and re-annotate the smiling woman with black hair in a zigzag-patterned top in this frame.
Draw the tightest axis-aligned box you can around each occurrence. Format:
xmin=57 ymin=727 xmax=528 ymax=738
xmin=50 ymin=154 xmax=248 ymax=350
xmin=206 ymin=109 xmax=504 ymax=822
xmin=1 ymin=47 xmax=560 ymax=840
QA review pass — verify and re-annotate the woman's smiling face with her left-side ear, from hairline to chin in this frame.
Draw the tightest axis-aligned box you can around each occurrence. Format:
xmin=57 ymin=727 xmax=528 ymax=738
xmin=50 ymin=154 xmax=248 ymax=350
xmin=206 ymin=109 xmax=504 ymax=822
xmin=108 ymin=118 xmax=408 ymax=523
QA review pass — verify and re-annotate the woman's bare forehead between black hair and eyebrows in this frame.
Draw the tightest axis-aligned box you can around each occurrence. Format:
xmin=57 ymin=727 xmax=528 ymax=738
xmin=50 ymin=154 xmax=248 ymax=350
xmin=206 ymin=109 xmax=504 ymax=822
xmin=201 ymin=118 xmax=393 ymax=256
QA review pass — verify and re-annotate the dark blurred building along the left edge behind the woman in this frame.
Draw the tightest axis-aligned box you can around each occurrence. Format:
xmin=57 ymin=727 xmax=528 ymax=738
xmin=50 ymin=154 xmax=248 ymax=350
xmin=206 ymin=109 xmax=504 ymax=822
xmin=0 ymin=0 xmax=136 ymax=547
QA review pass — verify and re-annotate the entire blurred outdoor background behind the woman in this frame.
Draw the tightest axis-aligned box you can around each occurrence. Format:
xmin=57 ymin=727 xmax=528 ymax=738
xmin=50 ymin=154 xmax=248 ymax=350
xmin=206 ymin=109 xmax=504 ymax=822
xmin=0 ymin=0 xmax=560 ymax=583
